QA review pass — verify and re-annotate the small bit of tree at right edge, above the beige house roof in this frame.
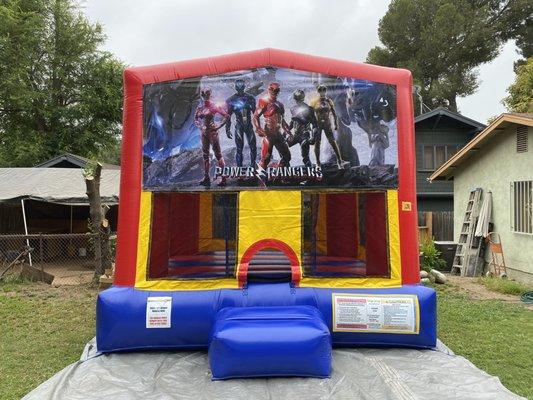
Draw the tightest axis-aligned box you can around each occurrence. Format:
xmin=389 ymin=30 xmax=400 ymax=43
xmin=503 ymin=57 xmax=533 ymax=113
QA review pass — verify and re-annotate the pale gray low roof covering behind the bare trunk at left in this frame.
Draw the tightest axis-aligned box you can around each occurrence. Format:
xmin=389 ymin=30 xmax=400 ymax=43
xmin=0 ymin=168 xmax=120 ymax=205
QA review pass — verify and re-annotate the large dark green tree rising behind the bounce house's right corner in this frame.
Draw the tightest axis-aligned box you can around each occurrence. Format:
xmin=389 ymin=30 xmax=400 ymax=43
xmin=367 ymin=0 xmax=533 ymax=111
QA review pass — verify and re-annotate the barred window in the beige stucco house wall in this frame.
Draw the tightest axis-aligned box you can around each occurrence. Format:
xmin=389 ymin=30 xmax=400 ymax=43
xmin=511 ymin=181 xmax=533 ymax=234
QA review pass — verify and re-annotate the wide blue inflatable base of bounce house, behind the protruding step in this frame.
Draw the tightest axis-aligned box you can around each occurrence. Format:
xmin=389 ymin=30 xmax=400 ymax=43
xmin=96 ymin=283 xmax=437 ymax=353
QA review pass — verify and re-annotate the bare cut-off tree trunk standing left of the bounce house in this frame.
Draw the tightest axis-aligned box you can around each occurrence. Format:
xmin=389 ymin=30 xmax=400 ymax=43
xmin=85 ymin=163 xmax=109 ymax=283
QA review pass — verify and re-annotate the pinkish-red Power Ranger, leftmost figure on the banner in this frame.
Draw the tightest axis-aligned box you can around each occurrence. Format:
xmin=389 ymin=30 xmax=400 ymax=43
xmin=194 ymin=88 xmax=229 ymax=186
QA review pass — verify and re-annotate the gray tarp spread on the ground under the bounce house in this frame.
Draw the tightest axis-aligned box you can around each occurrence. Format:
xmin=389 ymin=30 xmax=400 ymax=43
xmin=23 ymin=343 xmax=521 ymax=400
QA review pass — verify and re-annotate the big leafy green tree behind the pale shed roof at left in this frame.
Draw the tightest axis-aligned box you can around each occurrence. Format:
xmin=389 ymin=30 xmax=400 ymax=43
xmin=0 ymin=0 xmax=124 ymax=166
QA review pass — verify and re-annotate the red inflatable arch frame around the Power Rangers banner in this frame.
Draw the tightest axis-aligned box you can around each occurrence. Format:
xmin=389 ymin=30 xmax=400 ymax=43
xmin=114 ymin=49 xmax=419 ymax=286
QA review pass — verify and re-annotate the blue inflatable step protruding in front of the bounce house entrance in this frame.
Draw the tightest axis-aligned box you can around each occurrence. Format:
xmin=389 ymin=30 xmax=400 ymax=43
xmin=208 ymin=306 xmax=331 ymax=380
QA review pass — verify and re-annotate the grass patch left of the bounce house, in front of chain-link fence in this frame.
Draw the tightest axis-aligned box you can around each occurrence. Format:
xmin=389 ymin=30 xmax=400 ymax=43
xmin=0 ymin=283 xmax=96 ymax=400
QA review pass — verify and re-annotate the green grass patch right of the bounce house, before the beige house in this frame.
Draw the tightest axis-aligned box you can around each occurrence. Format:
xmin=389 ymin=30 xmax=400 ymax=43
xmin=436 ymin=285 xmax=533 ymax=399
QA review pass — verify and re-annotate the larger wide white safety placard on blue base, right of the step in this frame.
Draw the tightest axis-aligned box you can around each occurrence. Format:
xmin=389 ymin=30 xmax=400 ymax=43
xmin=332 ymin=293 xmax=419 ymax=334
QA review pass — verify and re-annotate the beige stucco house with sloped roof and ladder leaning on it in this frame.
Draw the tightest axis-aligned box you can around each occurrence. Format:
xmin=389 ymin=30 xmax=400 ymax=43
xmin=429 ymin=114 xmax=533 ymax=283
